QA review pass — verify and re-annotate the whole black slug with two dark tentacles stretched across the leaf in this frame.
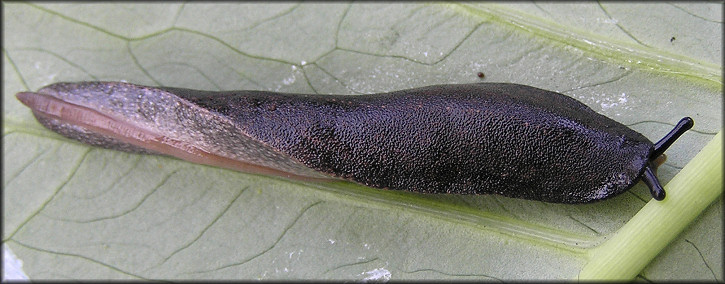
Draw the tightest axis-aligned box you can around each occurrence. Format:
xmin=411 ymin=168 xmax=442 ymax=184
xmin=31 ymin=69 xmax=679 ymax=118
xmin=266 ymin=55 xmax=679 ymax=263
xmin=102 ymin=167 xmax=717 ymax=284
xmin=17 ymin=82 xmax=693 ymax=203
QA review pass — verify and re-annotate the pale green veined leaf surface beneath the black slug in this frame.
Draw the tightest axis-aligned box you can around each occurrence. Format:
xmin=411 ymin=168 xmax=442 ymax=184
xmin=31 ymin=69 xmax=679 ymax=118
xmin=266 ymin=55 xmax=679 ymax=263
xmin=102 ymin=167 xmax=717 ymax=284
xmin=2 ymin=2 xmax=723 ymax=281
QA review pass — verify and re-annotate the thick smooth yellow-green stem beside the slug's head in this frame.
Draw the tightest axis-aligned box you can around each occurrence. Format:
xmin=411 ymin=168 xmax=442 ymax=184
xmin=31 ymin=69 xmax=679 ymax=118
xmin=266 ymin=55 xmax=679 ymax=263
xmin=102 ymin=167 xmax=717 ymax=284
xmin=579 ymin=131 xmax=723 ymax=280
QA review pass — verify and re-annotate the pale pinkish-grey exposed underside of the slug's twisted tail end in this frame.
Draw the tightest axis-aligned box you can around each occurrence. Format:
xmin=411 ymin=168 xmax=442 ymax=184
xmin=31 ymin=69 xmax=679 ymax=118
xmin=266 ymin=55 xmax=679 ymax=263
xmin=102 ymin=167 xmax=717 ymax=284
xmin=16 ymin=83 xmax=333 ymax=181
